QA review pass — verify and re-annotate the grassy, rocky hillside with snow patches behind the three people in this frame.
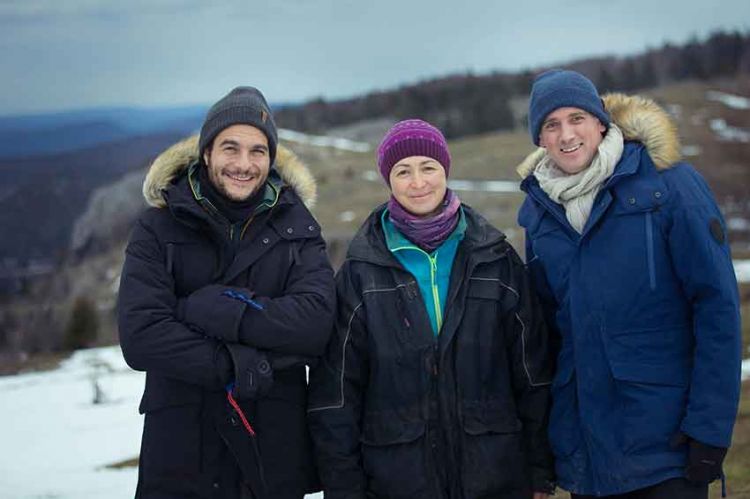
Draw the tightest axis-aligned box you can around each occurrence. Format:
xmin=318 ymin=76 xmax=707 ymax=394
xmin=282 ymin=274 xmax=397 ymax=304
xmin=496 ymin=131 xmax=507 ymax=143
xmin=0 ymin=79 xmax=750 ymax=360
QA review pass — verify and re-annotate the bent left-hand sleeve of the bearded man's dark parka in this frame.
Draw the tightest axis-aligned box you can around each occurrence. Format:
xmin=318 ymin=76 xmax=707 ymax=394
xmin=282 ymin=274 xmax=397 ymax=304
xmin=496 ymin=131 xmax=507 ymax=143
xmin=117 ymin=220 xmax=239 ymax=390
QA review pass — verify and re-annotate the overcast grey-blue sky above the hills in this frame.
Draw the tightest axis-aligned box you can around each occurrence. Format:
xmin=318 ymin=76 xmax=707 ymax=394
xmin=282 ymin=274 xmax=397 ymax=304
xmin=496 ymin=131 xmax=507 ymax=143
xmin=0 ymin=0 xmax=750 ymax=115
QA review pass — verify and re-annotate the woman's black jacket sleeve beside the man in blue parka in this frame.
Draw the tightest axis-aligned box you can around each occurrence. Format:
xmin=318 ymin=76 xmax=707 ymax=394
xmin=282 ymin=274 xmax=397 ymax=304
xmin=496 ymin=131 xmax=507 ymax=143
xmin=503 ymin=250 xmax=555 ymax=492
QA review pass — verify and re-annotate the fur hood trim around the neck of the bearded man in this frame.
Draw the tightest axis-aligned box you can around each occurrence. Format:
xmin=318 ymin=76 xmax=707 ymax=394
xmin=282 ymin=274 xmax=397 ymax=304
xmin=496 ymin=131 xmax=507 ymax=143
xmin=143 ymin=135 xmax=317 ymax=208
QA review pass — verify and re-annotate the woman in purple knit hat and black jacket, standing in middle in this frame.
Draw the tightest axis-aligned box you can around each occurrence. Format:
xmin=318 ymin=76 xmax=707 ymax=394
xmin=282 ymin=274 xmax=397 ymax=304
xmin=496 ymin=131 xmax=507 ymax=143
xmin=308 ymin=119 xmax=554 ymax=499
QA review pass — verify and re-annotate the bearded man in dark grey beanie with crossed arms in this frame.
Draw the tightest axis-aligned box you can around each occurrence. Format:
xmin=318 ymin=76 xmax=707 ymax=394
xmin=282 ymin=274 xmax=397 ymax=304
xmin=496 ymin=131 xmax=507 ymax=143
xmin=118 ymin=87 xmax=335 ymax=499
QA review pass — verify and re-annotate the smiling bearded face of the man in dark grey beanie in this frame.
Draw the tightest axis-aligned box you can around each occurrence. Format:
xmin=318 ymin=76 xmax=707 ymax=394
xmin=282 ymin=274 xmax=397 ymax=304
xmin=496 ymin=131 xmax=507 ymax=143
xmin=203 ymin=125 xmax=271 ymax=201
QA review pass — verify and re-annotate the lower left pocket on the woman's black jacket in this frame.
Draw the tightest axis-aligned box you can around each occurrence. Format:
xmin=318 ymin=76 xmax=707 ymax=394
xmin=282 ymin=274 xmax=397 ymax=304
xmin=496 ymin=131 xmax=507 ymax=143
xmin=361 ymin=411 xmax=433 ymax=499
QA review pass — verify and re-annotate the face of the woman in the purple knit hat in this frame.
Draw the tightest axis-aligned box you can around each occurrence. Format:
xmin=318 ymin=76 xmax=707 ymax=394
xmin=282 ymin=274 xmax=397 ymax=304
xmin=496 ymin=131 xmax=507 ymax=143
xmin=389 ymin=156 xmax=447 ymax=217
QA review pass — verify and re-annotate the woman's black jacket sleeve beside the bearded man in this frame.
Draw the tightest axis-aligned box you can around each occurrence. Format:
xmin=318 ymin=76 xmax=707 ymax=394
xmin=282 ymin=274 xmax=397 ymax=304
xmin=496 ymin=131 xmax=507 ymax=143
xmin=308 ymin=263 xmax=368 ymax=499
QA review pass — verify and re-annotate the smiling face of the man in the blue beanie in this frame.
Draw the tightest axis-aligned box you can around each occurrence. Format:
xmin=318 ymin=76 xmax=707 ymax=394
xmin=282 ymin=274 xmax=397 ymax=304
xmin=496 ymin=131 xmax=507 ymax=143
xmin=539 ymin=107 xmax=606 ymax=175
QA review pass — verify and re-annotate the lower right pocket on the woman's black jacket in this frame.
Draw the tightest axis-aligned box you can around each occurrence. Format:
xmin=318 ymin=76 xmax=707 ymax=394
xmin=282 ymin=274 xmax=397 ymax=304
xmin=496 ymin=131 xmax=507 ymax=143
xmin=461 ymin=403 xmax=528 ymax=498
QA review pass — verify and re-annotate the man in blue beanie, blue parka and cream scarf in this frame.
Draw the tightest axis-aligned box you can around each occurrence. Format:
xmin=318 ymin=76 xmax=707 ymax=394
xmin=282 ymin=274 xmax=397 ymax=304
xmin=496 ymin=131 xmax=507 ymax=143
xmin=518 ymin=70 xmax=741 ymax=499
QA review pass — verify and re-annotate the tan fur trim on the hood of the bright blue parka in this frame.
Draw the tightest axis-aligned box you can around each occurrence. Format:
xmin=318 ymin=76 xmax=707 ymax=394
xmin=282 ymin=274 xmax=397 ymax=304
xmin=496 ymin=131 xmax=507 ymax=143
xmin=516 ymin=93 xmax=681 ymax=178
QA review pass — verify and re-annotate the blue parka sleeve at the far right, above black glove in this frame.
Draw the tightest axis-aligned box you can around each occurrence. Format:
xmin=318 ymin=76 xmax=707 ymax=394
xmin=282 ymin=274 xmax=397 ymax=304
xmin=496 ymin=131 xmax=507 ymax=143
xmin=668 ymin=165 xmax=742 ymax=447
